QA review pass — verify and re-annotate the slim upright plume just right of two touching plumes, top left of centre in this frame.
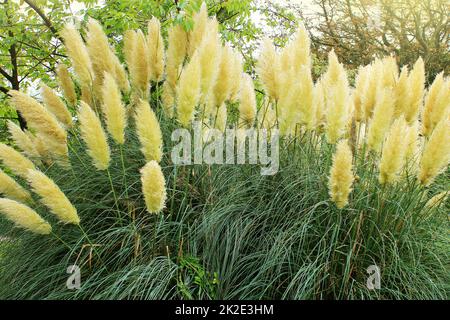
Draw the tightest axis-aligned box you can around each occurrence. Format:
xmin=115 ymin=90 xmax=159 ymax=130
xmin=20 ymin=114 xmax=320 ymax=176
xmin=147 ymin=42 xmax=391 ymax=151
xmin=147 ymin=17 xmax=164 ymax=82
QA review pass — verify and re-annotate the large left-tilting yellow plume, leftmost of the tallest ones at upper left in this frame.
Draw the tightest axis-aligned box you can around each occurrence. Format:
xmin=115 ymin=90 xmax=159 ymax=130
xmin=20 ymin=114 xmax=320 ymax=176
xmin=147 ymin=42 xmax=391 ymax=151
xmin=61 ymin=24 xmax=94 ymax=86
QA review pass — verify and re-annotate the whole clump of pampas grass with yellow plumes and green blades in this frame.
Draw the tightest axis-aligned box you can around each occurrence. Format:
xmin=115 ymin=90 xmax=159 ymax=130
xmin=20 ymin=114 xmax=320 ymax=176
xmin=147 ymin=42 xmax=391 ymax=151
xmin=0 ymin=5 xmax=450 ymax=299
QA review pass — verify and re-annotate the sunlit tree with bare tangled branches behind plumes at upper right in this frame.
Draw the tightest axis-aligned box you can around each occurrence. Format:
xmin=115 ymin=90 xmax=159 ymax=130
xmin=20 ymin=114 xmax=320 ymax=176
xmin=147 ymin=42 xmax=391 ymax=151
xmin=298 ymin=0 xmax=450 ymax=83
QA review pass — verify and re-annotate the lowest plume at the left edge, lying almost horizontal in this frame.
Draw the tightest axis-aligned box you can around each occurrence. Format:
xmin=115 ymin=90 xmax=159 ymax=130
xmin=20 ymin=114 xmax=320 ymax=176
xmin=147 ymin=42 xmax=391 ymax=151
xmin=0 ymin=198 xmax=52 ymax=234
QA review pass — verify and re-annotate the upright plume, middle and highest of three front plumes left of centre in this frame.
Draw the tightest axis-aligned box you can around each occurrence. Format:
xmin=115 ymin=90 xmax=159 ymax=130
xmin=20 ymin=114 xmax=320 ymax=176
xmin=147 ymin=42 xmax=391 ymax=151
xmin=102 ymin=73 xmax=127 ymax=144
